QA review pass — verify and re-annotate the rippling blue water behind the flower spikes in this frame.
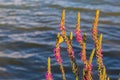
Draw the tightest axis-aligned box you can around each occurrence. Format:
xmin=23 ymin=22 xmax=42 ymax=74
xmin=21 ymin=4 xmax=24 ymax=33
xmin=0 ymin=0 xmax=120 ymax=80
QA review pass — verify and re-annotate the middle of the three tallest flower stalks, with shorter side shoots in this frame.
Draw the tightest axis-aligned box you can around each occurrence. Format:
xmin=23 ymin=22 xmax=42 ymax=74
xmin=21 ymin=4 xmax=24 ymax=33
xmin=75 ymin=12 xmax=94 ymax=80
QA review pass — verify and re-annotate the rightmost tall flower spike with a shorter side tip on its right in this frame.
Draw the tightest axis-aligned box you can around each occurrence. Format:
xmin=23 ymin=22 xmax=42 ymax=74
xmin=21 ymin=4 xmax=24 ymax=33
xmin=92 ymin=10 xmax=107 ymax=80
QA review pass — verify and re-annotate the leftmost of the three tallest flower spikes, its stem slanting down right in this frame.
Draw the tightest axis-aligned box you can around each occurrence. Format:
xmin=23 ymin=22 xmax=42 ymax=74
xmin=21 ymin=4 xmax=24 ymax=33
xmin=60 ymin=10 xmax=79 ymax=80
